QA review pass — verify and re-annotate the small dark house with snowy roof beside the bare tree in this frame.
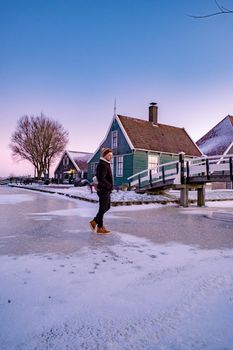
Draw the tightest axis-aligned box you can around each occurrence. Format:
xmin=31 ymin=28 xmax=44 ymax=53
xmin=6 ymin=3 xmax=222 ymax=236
xmin=54 ymin=150 xmax=92 ymax=183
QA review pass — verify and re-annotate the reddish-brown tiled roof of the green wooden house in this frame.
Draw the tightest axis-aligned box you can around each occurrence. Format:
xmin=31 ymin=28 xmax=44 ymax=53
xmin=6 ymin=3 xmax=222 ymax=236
xmin=118 ymin=115 xmax=201 ymax=156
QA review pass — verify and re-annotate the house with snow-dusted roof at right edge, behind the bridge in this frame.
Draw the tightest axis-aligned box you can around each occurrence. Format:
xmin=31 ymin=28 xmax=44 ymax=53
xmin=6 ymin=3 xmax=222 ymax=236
xmin=197 ymin=115 xmax=233 ymax=189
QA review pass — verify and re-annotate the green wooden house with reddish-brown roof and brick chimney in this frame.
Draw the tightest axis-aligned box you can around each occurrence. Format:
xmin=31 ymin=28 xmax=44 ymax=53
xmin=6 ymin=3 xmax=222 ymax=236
xmin=88 ymin=103 xmax=201 ymax=186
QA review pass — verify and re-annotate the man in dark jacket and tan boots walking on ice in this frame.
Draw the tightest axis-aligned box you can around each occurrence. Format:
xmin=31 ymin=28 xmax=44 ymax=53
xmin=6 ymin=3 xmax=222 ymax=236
xmin=90 ymin=148 xmax=113 ymax=234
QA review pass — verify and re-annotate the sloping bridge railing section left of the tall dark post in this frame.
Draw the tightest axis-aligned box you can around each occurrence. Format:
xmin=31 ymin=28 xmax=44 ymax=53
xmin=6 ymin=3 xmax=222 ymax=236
xmin=128 ymin=160 xmax=180 ymax=188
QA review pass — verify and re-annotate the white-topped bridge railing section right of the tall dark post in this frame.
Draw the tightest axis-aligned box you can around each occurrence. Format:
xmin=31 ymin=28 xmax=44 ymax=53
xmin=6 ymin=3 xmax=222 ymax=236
xmin=185 ymin=154 xmax=233 ymax=180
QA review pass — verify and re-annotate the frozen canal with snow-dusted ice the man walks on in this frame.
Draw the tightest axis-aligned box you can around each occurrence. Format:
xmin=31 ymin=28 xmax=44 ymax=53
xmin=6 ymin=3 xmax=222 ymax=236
xmin=0 ymin=187 xmax=233 ymax=350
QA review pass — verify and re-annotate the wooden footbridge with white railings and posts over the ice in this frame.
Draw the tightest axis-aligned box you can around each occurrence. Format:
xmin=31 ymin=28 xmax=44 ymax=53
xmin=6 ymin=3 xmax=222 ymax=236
xmin=128 ymin=153 xmax=233 ymax=207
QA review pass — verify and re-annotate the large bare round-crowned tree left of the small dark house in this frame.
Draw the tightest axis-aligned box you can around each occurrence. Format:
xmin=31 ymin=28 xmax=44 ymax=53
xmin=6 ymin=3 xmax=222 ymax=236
xmin=10 ymin=114 xmax=68 ymax=179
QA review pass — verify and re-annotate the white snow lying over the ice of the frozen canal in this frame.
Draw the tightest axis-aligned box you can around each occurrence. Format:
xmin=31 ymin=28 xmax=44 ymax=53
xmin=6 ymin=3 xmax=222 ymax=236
xmin=0 ymin=189 xmax=233 ymax=350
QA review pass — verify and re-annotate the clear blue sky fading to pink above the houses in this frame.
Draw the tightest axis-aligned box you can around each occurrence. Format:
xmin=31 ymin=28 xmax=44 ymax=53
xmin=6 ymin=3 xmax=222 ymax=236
xmin=0 ymin=0 xmax=233 ymax=176
